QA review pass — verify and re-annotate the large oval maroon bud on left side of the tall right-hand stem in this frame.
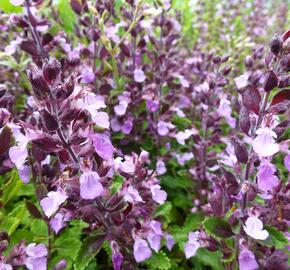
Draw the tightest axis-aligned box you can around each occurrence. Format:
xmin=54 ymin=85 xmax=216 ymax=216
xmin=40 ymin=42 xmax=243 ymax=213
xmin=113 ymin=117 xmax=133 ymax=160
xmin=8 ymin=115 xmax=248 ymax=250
xmin=242 ymin=85 xmax=261 ymax=115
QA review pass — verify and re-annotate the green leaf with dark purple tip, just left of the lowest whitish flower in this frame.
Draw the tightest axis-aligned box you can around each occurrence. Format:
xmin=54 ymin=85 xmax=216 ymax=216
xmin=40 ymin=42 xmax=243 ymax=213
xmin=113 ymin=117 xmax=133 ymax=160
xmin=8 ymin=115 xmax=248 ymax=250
xmin=203 ymin=217 xmax=234 ymax=239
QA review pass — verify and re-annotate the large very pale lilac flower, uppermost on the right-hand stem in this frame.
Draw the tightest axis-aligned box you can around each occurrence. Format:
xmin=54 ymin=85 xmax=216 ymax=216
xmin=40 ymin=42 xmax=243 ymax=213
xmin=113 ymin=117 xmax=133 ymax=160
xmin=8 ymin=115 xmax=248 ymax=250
xmin=253 ymin=127 xmax=279 ymax=157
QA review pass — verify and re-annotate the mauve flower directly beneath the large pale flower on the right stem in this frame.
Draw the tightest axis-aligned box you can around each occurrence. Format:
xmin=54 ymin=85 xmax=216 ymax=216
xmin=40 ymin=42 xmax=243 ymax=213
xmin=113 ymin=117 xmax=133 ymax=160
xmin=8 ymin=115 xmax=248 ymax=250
xmin=257 ymin=160 xmax=279 ymax=199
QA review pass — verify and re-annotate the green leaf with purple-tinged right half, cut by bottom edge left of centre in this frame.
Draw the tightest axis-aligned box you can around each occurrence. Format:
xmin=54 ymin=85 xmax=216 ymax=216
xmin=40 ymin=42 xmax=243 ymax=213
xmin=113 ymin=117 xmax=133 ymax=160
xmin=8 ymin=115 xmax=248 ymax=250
xmin=74 ymin=234 xmax=106 ymax=270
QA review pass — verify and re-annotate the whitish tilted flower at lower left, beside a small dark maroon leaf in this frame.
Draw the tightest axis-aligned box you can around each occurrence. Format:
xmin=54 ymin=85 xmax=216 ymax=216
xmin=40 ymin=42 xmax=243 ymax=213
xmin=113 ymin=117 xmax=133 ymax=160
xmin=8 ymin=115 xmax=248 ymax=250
xmin=40 ymin=189 xmax=68 ymax=217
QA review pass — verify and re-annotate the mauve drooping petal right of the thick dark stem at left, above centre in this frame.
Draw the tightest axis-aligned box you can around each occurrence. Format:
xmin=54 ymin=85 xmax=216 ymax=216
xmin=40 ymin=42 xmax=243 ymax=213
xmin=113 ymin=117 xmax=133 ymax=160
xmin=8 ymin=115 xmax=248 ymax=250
xmin=91 ymin=134 xmax=115 ymax=161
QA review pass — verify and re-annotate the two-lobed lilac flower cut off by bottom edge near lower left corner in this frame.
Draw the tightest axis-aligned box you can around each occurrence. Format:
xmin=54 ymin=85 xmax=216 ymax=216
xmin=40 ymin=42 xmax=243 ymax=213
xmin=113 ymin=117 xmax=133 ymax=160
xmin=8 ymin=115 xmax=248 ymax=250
xmin=25 ymin=243 xmax=47 ymax=270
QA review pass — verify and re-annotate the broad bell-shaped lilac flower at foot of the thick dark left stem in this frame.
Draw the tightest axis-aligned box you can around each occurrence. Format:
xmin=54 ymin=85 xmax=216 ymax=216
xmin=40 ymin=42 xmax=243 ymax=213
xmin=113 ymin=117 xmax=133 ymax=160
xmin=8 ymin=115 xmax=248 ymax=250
xmin=80 ymin=171 xmax=104 ymax=200
